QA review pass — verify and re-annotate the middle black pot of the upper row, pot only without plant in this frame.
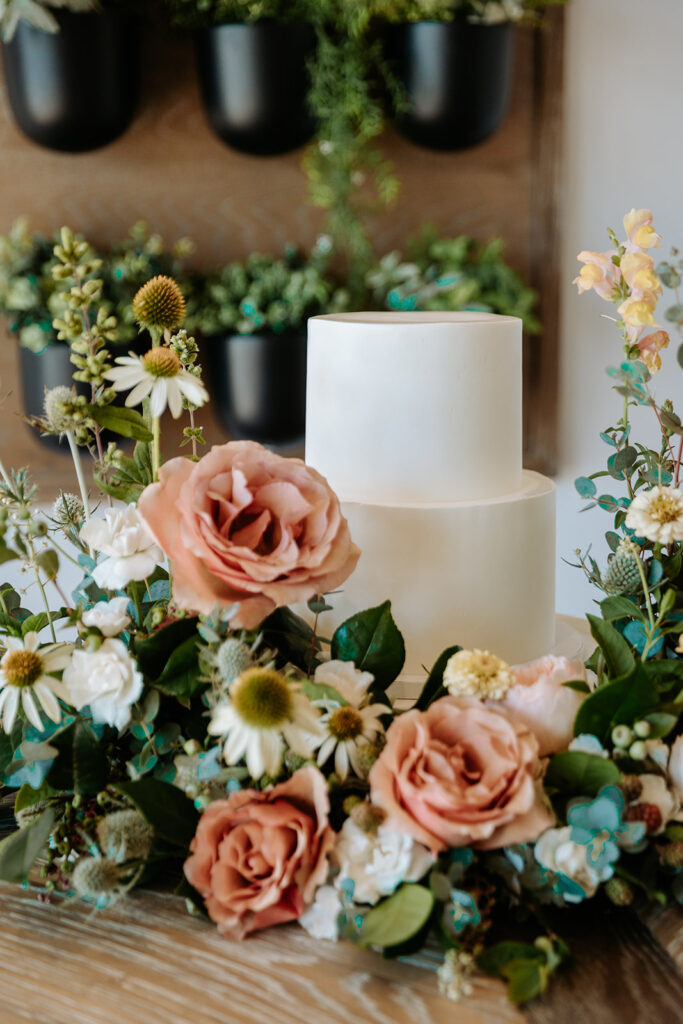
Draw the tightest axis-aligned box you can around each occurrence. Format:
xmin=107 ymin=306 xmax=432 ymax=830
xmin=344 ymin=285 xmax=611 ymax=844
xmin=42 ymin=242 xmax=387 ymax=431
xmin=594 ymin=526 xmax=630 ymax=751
xmin=197 ymin=22 xmax=315 ymax=157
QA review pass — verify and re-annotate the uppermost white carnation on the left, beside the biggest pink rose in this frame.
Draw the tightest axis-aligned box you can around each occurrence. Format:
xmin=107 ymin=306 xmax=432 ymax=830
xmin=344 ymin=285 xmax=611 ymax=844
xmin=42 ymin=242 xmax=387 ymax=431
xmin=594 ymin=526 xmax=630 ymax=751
xmin=80 ymin=505 xmax=164 ymax=590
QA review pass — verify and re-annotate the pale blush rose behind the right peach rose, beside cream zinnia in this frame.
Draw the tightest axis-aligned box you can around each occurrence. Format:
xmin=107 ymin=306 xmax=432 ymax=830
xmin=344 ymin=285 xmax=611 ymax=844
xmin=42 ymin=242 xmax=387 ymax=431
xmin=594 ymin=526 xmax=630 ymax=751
xmin=498 ymin=654 xmax=586 ymax=758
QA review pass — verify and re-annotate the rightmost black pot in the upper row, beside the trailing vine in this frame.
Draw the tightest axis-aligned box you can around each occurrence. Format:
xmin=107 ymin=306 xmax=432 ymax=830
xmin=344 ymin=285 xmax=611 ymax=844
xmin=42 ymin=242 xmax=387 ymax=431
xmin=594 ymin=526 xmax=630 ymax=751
xmin=386 ymin=18 xmax=514 ymax=151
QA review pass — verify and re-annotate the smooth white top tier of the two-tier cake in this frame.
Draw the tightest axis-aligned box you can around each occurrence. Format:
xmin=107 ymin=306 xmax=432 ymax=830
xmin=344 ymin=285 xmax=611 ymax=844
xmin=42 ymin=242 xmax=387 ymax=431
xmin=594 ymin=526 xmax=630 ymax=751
xmin=306 ymin=312 xmax=522 ymax=505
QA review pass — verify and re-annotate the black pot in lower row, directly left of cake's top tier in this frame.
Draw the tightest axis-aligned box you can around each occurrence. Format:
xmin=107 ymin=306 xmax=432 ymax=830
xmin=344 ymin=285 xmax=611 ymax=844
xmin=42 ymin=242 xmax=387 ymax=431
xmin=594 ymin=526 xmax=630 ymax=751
xmin=206 ymin=333 xmax=306 ymax=445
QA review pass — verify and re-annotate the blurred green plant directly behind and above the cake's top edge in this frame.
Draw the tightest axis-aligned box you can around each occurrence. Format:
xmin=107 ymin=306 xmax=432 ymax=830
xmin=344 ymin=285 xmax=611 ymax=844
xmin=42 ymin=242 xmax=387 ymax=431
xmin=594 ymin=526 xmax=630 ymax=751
xmin=367 ymin=226 xmax=540 ymax=334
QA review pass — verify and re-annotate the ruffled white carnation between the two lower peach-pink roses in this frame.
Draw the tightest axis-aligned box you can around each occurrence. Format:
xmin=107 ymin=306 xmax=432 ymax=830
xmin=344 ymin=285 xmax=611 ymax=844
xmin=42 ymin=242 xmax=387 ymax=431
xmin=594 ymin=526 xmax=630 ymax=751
xmin=333 ymin=818 xmax=434 ymax=903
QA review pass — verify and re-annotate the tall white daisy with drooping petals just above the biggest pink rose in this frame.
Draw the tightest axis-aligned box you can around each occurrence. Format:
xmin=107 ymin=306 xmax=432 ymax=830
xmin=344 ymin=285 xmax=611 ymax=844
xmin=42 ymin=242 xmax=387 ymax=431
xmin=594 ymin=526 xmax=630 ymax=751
xmin=104 ymin=345 xmax=209 ymax=420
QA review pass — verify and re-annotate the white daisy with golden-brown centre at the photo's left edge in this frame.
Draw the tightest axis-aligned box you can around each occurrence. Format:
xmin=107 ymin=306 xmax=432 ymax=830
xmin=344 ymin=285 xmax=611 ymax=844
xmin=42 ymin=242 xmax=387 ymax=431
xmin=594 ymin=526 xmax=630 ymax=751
xmin=0 ymin=632 xmax=72 ymax=733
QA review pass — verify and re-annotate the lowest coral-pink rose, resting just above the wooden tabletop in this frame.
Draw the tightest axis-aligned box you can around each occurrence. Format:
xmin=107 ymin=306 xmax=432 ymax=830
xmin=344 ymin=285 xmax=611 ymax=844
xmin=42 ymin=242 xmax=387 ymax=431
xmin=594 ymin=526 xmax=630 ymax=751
xmin=184 ymin=767 xmax=335 ymax=939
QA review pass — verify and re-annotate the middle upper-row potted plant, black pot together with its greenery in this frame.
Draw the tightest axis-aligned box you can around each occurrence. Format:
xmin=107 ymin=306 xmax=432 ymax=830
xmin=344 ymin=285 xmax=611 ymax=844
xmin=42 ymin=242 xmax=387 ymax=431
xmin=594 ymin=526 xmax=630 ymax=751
xmin=166 ymin=0 xmax=315 ymax=156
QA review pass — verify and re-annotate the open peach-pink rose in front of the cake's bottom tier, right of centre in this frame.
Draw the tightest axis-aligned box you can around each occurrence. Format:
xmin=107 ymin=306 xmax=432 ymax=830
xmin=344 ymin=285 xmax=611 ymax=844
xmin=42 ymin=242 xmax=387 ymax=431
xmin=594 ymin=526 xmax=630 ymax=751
xmin=370 ymin=697 xmax=554 ymax=853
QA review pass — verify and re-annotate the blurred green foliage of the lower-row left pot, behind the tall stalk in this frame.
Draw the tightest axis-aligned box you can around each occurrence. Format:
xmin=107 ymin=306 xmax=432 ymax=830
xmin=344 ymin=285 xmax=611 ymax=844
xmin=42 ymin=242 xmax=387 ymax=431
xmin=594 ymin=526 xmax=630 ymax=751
xmin=0 ymin=218 xmax=197 ymax=352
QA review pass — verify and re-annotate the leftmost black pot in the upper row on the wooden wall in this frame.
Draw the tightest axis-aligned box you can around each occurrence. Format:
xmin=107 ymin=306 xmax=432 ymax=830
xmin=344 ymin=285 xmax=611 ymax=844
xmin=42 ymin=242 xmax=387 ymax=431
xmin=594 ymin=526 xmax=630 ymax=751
xmin=2 ymin=9 xmax=139 ymax=153
